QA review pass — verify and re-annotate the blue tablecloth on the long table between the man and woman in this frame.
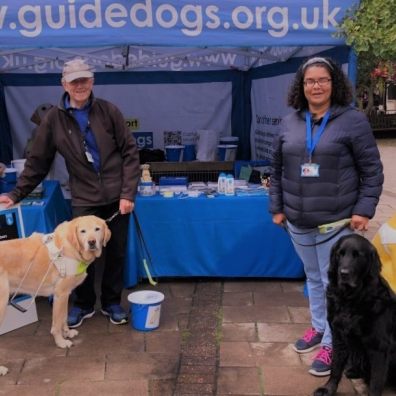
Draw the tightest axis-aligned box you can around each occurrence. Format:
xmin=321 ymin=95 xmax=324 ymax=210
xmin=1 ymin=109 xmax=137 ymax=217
xmin=125 ymin=195 xmax=304 ymax=287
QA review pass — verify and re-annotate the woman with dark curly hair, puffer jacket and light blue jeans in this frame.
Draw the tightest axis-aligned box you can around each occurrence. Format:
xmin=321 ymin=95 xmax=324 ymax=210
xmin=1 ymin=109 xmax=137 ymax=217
xmin=270 ymin=57 xmax=384 ymax=376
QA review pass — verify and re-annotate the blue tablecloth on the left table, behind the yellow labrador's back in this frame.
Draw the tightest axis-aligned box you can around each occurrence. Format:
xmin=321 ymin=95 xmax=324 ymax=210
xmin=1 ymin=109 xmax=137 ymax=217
xmin=22 ymin=180 xmax=71 ymax=236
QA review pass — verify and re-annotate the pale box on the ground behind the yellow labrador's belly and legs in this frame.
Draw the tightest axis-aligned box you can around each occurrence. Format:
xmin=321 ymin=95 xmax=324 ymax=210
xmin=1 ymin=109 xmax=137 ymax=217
xmin=0 ymin=294 xmax=38 ymax=335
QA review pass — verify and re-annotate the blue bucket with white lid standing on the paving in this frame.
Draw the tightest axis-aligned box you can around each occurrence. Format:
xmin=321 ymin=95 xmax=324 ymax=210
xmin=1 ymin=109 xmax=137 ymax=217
xmin=128 ymin=290 xmax=165 ymax=331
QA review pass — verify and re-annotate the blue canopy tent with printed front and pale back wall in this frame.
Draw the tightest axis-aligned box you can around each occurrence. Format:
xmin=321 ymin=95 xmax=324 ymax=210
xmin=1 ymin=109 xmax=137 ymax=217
xmin=0 ymin=0 xmax=357 ymax=162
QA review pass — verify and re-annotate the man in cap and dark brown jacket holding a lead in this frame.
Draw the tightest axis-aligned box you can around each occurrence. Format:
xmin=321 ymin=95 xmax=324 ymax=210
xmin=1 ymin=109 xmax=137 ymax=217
xmin=0 ymin=59 xmax=140 ymax=328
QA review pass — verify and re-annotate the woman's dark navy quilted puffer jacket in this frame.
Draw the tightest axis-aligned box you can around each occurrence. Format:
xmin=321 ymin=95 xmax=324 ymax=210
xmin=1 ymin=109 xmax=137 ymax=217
xmin=269 ymin=106 xmax=384 ymax=228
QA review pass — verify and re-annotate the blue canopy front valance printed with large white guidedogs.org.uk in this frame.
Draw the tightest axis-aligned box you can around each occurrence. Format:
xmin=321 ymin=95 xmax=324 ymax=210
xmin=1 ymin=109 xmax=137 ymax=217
xmin=0 ymin=0 xmax=358 ymax=49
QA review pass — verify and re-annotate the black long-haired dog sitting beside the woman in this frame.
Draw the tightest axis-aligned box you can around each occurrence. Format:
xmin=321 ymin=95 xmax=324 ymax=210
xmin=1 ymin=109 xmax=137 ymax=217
xmin=314 ymin=234 xmax=396 ymax=396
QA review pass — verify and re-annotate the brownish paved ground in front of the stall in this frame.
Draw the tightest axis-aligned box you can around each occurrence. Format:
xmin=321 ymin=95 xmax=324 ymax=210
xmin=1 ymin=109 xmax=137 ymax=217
xmin=0 ymin=140 xmax=396 ymax=396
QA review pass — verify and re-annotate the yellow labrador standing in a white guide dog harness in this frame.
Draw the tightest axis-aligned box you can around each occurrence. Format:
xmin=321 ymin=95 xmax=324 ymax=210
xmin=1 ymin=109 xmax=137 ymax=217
xmin=0 ymin=216 xmax=111 ymax=375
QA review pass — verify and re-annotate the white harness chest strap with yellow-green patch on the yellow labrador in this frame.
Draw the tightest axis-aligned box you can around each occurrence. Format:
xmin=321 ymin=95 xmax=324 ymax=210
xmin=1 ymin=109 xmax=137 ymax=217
xmin=43 ymin=234 xmax=88 ymax=278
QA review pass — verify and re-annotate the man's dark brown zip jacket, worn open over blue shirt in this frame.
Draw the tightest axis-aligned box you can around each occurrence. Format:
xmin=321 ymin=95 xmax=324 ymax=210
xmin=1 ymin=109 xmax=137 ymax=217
xmin=8 ymin=93 xmax=140 ymax=206
